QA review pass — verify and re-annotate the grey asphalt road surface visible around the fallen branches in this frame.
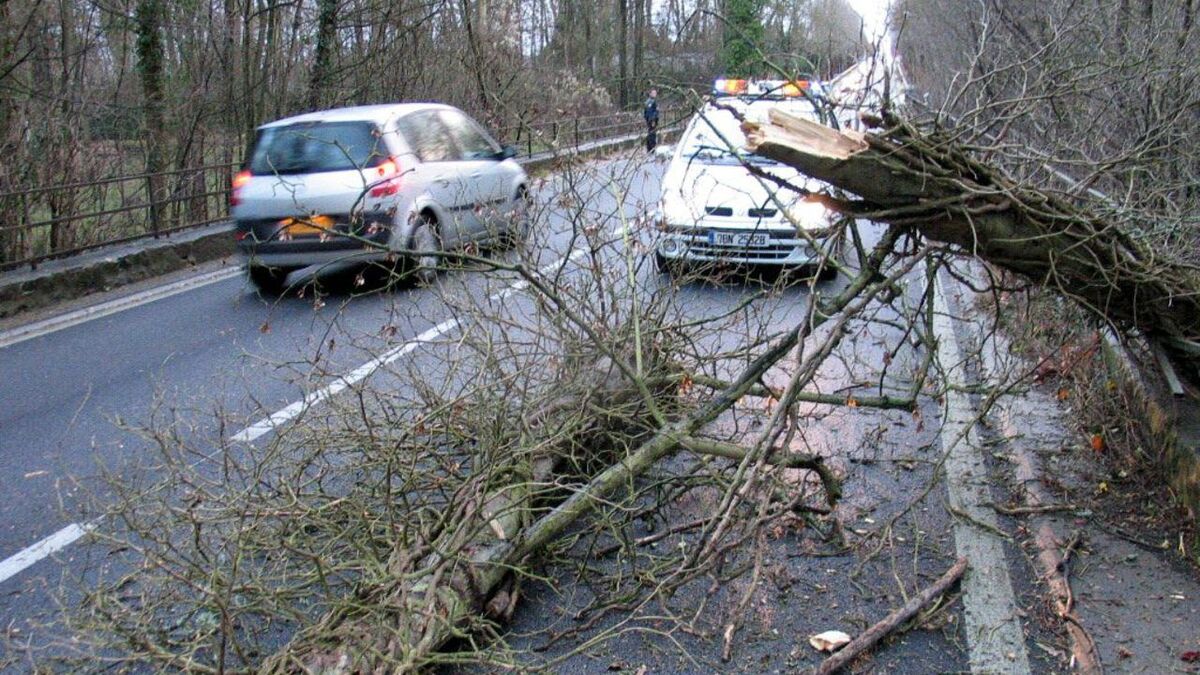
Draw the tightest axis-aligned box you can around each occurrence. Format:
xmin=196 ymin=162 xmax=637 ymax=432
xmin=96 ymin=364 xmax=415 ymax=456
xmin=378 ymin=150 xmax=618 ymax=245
xmin=0 ymin=148 xmax=1036 ymax=670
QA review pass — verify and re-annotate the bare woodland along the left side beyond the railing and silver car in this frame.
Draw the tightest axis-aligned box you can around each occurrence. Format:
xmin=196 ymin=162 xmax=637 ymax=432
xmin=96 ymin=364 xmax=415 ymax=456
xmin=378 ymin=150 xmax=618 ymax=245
xmin=0 ymin=0 xmax=859 ymax=267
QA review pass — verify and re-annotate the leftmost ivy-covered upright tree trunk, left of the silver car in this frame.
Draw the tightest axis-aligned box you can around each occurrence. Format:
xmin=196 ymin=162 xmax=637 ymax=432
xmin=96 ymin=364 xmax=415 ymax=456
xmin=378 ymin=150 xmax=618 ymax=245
xmin=136 ymin=0 xmax=167 ymax=235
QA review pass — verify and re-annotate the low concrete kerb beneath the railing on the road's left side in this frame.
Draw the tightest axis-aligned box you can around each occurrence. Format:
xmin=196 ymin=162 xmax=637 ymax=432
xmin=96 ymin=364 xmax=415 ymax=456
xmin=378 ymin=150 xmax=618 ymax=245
xmin=0 ymin=129 xmax=678 ymax=318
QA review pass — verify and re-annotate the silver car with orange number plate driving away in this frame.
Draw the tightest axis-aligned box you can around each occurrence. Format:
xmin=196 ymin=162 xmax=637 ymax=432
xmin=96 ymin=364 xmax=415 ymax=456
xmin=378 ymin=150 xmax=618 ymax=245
xmin=230 ymin=103 xmax=529 ymax=293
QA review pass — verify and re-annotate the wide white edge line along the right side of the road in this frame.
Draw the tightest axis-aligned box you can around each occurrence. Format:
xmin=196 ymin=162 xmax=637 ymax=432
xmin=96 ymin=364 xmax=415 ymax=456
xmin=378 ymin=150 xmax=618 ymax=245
xmin=934 ymin=273 xmax=1030 ymax=674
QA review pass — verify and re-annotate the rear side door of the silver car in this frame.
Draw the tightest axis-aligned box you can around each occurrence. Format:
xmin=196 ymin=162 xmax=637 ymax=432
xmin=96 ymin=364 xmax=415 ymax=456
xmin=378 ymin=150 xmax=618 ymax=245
xmin=397 ymin=108 xmax=465 ymax=247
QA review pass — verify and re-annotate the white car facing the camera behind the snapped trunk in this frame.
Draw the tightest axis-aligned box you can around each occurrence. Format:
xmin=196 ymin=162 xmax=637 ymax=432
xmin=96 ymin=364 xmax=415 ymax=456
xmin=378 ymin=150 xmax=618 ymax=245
xmin=654 ymin=88 xmax=836 ymax=271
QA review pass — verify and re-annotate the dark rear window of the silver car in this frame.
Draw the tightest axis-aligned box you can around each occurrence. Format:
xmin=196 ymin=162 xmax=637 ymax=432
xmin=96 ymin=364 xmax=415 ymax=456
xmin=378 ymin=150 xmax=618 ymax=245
xmin=250 ymin=121 xmax=389 ymax=175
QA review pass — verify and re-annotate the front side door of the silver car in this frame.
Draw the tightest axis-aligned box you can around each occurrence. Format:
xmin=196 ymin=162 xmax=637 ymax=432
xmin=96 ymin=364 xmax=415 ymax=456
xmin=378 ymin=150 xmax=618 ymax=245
xmin=438 ymin=108 xmax=510 ymax=239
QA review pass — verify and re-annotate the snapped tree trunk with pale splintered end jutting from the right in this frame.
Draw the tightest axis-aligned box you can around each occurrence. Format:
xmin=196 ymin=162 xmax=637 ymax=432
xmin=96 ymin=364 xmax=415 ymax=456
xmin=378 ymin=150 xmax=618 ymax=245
xmin=744 ymin=110 xmax=1200 ymax=364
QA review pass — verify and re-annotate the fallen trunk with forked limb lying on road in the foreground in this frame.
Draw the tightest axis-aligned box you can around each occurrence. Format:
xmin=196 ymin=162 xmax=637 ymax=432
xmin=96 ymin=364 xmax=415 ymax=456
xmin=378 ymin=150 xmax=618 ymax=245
xmin=260 ymin=229 xmax=922 ymax=674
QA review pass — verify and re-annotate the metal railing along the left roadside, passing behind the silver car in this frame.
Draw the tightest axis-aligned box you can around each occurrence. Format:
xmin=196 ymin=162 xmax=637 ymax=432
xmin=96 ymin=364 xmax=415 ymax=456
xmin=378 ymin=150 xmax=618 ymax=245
xmin=0 ymin=112 xmax=662 ymax=271
